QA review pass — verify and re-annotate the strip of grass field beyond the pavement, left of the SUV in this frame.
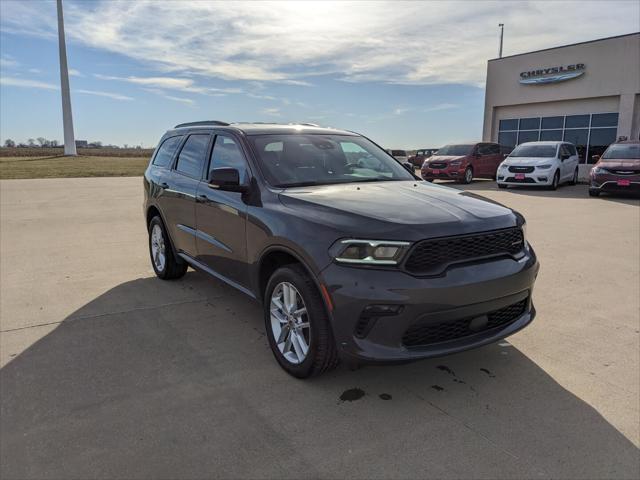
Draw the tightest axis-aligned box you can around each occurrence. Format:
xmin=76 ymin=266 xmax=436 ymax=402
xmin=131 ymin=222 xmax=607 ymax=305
xmin=0 ymin=154 xmax=150 ymax=180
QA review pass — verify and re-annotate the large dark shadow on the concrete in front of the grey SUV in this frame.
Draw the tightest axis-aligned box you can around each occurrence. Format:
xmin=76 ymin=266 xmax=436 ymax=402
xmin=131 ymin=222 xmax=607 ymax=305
xmin=0 ymin=272 xmax=640 ymax=479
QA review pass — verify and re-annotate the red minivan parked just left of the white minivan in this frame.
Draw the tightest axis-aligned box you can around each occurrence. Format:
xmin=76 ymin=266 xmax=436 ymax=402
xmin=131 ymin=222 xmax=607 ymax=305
xmin=422 ymin=143 xmax=509 ymax=183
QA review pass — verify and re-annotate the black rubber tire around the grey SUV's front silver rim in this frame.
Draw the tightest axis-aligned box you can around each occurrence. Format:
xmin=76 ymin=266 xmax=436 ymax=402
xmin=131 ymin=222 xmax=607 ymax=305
xmin=263 ymin=264 xmax=339 ymax=378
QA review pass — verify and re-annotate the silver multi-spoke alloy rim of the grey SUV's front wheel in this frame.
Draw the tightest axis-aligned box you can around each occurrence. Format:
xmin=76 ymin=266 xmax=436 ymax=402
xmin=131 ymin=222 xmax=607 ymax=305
xmin=269 ymin=282 xmax=311 ymax=364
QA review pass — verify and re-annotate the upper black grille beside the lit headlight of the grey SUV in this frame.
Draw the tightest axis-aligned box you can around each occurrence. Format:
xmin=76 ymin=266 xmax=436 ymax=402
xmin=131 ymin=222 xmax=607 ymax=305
xmin=404 ymin=227 xmax=524 ymax=275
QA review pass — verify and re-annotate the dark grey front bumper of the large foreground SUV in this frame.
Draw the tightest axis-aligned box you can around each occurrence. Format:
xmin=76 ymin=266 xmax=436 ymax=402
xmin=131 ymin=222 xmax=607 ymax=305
xmin=321 ymin=247 xmax=539 ymax=363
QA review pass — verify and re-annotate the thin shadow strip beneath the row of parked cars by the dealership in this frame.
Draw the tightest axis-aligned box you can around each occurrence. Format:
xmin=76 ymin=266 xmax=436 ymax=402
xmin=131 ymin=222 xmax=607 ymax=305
xmin=437 ymin=180 xmax=640 ymax=206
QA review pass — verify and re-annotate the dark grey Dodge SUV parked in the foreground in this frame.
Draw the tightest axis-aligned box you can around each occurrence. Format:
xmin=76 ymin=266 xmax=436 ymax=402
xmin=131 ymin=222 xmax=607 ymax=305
xmin=144 ymin=122 xmax=538 ymax=377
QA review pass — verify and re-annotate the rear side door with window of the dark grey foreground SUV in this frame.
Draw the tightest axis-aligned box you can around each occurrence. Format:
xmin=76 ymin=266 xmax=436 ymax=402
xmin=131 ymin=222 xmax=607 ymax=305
xmin=161 ymin=133 xmax=211 ymax=257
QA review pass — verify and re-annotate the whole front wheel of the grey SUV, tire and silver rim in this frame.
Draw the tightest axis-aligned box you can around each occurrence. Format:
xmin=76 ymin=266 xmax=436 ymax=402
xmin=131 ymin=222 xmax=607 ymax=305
xmin=264 ymin=265 xmax=338 ymax=378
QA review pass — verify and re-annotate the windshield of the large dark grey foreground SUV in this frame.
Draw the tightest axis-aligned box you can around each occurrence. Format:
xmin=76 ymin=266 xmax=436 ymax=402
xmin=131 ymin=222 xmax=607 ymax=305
xmin=249 ymin=134 xmax=414 ymax=188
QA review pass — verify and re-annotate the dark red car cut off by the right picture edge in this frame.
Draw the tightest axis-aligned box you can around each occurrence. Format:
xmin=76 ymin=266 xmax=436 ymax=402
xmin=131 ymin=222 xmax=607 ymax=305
xmin=589 ymin=141 xmax=640 ymax=197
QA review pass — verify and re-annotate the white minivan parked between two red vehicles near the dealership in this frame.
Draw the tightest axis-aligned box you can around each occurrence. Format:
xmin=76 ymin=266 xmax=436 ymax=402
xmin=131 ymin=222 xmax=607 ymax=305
xmin=497 ymin=142 xmax=579 ymax=190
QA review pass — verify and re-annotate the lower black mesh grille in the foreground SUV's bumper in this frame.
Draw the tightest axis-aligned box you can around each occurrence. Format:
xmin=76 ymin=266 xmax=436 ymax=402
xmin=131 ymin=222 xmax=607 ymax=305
xmin=402 ymin=298 xmax=529 ymax=347
